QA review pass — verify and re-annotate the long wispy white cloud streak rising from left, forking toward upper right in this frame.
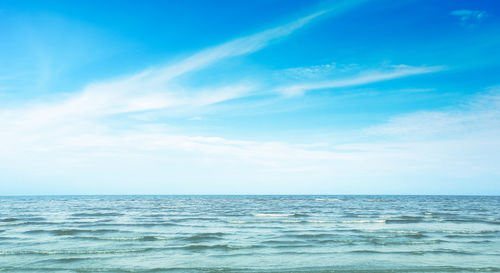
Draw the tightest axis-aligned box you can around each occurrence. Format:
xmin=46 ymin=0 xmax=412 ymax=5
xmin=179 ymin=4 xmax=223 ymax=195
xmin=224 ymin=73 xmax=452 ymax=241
xmin=4 ymin=7 xmax=326 ymax=127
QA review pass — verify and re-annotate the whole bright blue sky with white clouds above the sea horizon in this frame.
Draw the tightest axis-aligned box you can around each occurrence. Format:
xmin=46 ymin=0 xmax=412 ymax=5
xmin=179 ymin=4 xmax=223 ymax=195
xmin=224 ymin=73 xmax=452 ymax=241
xmin=0 ymin=0 xmax=500 ymax=195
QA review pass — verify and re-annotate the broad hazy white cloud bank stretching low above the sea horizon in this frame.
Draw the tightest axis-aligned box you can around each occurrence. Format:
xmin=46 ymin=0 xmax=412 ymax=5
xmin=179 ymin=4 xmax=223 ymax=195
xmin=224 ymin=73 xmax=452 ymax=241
xmin=0 ymin=87 xmax=500 ymax=193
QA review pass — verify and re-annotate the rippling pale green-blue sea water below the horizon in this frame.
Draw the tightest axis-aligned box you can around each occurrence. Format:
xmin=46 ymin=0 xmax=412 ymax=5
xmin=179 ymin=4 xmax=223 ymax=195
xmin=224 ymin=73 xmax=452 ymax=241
xmin=0 ymin=196 xmax=500 ymax=273
